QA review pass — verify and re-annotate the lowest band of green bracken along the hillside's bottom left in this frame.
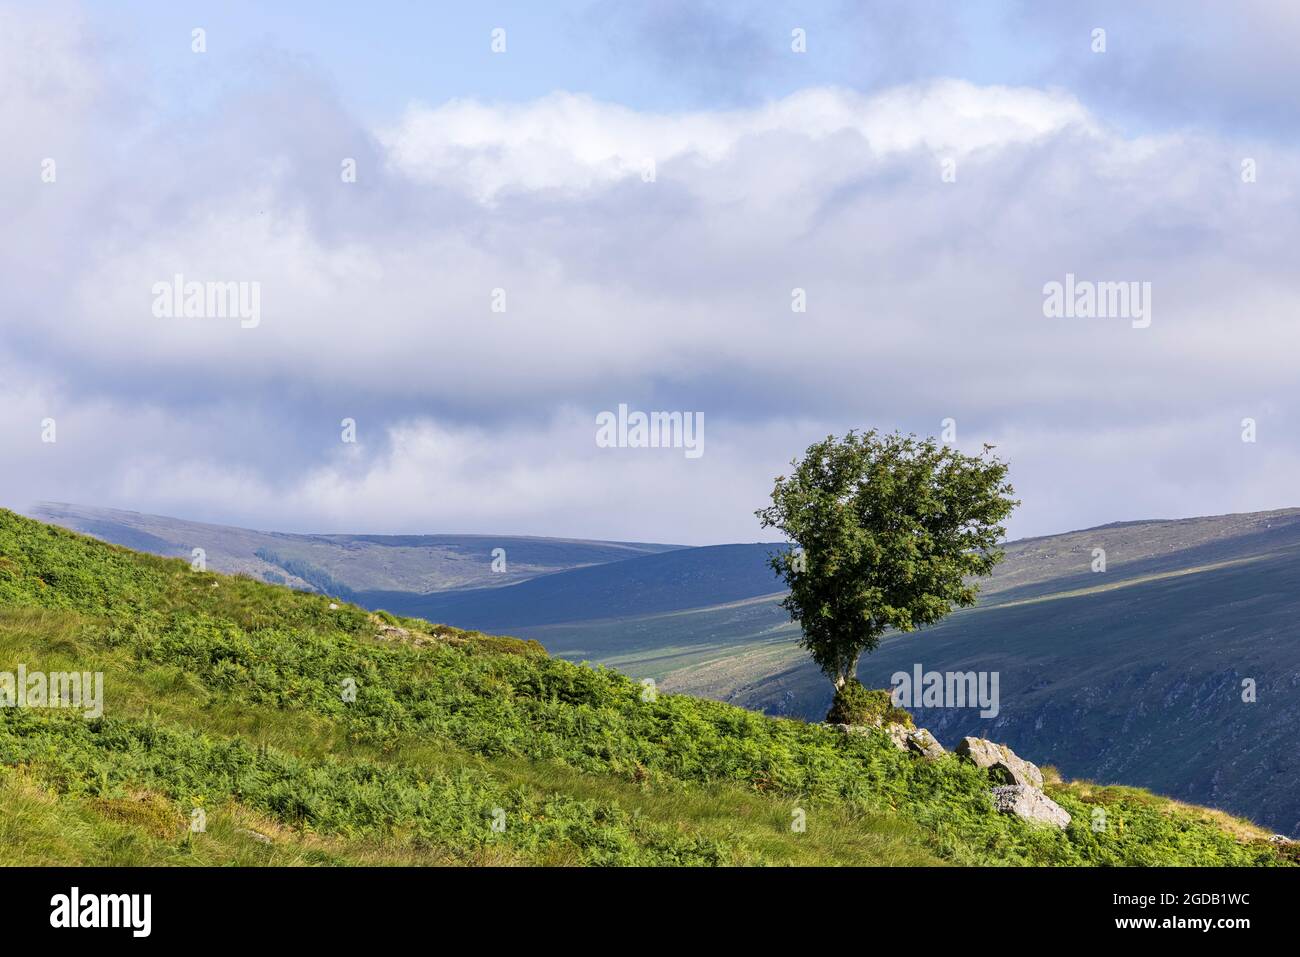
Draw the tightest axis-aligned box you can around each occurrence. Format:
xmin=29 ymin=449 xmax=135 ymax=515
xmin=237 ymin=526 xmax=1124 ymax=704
xmin=0 ymin=711 xmax=723 ymax=865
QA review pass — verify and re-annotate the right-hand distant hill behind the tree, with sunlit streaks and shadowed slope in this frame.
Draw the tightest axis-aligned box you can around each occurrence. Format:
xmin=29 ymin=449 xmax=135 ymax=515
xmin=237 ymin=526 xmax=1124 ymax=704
xmin=514 ymin=510 xmax=1300 ymax=836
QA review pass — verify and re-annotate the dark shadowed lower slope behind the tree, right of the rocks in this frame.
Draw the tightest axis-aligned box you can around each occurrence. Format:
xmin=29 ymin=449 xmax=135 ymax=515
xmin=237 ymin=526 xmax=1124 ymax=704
xmin=738 ymin=547 xmax=1300 ymax=835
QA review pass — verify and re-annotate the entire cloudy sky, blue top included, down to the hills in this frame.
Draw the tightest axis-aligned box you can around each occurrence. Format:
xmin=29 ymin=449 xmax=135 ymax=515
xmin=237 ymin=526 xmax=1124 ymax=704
xmin=0 ymin=0 xmax=1300 ymax=544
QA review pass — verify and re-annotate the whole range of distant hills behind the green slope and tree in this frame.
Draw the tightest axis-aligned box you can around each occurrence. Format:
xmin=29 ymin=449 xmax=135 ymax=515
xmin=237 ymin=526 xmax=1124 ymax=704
xmin=27 ymin=501 xmax=1300 ymax=835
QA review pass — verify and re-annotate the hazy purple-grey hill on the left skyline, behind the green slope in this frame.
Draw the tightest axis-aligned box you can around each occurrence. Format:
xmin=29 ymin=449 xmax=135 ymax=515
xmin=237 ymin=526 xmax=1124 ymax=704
xmin=29 ymin=502 xmax=681 ymax=596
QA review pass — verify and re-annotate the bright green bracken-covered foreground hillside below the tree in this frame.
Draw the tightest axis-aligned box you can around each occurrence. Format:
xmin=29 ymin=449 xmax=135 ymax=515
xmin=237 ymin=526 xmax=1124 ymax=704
xmin=0 ymin=511 xmax=1287 ymax=865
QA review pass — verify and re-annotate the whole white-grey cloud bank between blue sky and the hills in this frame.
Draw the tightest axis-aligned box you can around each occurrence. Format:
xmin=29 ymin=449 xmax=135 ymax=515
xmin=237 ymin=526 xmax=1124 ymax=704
xmin=0 ymin=7 xmax=1300 ymax=542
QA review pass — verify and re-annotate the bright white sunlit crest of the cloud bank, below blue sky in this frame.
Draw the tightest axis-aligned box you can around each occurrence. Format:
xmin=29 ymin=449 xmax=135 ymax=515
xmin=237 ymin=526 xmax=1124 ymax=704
xmin=381 ymin=79 xmax=1089 ymax=202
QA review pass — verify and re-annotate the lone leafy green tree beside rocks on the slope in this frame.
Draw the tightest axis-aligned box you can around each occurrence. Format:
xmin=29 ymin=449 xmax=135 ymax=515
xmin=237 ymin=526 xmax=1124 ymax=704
xmin=755 ymin=429 xmax=1019 ymax=714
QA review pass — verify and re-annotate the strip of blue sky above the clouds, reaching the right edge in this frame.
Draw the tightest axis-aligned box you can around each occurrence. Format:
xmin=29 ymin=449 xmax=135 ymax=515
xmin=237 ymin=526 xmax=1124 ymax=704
xmin=98 ymin=0 xmax=1297 ymax=138
